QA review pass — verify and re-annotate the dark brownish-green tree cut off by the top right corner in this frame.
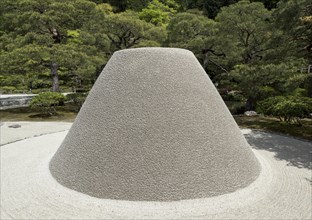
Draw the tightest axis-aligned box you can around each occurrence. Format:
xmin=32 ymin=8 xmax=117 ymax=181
xmin=265 ymin=0 xmax=312 ymax=97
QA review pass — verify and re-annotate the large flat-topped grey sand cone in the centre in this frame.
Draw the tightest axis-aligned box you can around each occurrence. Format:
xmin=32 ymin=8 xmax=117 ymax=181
xmin=50 ymin=48 xmax=260 ymax=201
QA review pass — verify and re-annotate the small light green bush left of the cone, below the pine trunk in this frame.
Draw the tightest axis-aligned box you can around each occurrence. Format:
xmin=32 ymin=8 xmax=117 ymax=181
xmin=30 ymin=92 xmax=65 ymax=115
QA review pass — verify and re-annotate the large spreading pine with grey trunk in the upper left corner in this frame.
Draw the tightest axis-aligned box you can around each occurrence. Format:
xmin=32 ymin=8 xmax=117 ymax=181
xmin=0 ymin=0 xmax=106 ymax=91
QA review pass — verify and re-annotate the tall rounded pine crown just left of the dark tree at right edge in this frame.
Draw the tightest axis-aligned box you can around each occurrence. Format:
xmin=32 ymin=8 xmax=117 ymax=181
xmin=216 ymin=1 xmax=271 ymax=66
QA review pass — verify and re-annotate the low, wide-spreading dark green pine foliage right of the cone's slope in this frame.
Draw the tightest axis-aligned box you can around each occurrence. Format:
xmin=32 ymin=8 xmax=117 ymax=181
xmin=230 ymin=60 xmax=307 ymax=110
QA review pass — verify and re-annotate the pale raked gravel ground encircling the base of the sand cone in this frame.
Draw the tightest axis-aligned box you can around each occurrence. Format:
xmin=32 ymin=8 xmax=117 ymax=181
xmin=1 ymin=129 xmax=312 ymax=219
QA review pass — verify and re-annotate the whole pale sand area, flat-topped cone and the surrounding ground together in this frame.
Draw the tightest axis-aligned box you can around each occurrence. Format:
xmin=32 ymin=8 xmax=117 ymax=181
xmin=1 ymin=48 xmax=312 ymax=219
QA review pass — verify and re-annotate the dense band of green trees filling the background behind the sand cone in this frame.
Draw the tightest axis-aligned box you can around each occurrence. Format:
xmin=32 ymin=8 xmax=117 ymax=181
xmin=0 ymin=0 xmax=312 ymax=117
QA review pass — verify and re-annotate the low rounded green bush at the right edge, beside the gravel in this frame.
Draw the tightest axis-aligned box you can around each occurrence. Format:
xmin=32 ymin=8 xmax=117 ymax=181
xmin=257 ymin=96 xmax=312 ymax=125
